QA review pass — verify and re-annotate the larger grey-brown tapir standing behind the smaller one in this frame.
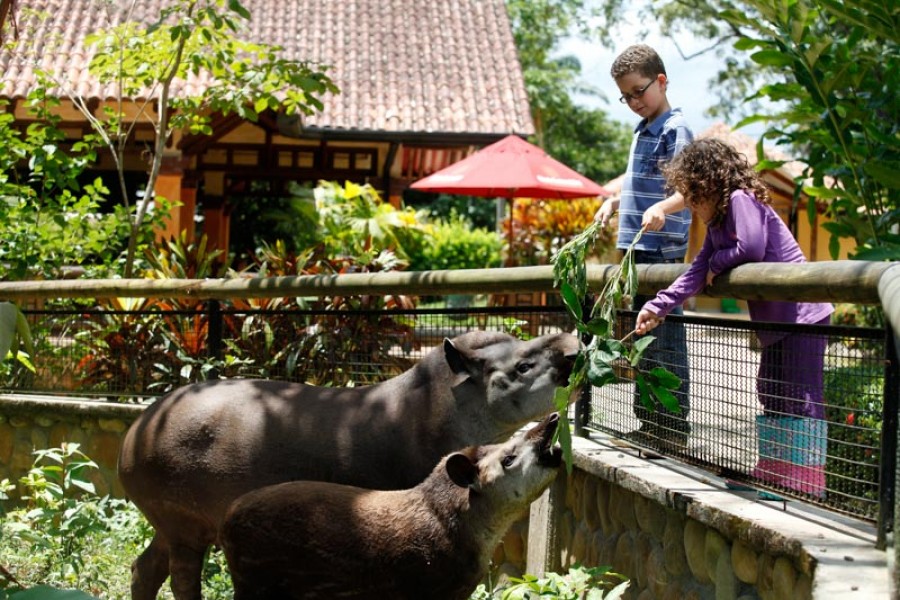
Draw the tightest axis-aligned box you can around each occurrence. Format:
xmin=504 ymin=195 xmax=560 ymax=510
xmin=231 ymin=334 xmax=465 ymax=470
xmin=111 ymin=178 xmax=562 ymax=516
xmin=119 ymin=332 xmax=579 ymax=600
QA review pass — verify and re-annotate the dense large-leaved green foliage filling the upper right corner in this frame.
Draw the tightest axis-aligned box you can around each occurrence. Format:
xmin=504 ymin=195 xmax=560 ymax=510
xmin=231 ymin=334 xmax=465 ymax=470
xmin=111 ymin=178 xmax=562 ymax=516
xmin=721 ymin=0 xmax=900 ymax=260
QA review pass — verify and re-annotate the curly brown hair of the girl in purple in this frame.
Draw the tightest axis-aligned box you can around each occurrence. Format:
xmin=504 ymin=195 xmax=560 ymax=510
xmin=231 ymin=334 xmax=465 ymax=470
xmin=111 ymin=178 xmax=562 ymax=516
xmin=662 ymin=138 xmax=770 ymax=225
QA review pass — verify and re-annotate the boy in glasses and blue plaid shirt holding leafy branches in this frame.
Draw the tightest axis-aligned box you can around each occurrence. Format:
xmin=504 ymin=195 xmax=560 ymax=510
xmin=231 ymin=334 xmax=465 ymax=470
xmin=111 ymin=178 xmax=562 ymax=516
xmin=594 ymin=44 xmax=694 ymax=450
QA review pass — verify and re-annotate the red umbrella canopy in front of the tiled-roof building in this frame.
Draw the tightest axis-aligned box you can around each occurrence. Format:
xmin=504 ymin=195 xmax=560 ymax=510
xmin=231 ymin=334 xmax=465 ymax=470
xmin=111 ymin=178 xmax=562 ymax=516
xmin=410 ymin=135 xmax=609 ymax=198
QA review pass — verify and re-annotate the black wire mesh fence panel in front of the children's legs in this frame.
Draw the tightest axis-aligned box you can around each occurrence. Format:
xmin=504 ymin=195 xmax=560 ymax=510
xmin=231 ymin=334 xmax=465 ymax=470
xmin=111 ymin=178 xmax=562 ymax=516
xmin=587 ymin=313 xmax=896 ymax=520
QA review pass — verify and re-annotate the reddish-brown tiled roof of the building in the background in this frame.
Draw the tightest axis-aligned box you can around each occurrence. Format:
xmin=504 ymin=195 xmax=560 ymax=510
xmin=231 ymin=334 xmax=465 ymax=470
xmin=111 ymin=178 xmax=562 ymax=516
xmin=0 ymin=0 xmax=534 ymax=136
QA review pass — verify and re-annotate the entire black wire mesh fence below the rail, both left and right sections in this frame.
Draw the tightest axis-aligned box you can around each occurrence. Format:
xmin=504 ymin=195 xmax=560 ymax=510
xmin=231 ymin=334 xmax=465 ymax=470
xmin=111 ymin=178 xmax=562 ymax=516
xmin=0 ymin=302 xmax=884 ymax=520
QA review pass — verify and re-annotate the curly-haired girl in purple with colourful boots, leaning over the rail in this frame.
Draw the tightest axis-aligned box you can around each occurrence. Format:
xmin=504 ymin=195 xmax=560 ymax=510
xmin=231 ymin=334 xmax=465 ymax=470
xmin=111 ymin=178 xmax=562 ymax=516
xmin=635 ymin=139 xmax=834 ymax=496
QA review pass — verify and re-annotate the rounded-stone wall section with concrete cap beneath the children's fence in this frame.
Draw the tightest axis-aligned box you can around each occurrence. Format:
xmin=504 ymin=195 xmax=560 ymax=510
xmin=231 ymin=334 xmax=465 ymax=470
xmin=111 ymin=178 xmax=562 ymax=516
xmin=526 ymin=436 xmax=894 ymax=600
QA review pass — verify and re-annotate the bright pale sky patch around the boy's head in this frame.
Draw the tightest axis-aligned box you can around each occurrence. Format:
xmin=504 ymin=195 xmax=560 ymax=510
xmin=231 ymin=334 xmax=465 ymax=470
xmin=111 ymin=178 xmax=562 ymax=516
xmin=559 ymin=8 xmax=762 ymax=137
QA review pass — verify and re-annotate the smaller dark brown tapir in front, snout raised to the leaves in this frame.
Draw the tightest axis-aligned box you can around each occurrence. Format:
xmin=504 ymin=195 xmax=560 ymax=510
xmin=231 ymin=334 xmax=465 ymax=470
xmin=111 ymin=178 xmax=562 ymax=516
xmin=219 ymin=413 xmax=562 ymax=600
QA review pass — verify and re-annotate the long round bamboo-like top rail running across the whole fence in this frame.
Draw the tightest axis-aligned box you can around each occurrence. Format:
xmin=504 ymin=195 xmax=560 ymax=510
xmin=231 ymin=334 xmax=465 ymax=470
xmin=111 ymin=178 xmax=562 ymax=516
xmin=0 ymin=260 xmax=891 ymax=304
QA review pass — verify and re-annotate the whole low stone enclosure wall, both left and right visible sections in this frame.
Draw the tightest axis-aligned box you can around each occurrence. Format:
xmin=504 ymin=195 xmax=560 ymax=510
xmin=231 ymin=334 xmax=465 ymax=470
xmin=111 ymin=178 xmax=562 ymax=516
xmin=0 ymin=396 xmax=890 ymax=600
